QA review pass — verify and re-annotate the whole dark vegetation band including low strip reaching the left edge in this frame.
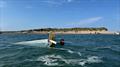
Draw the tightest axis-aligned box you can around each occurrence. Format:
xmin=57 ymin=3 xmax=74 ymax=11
xmin=0 ymin=27 xmax=108 ymax=34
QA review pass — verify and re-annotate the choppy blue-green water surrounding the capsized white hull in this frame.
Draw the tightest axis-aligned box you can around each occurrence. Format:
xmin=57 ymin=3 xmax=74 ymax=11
xmin=0 ymin=34 xmax=120 ymax=67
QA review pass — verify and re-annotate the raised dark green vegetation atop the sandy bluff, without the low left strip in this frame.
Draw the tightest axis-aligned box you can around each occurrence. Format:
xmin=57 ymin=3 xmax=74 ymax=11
xmin=24 ymin=27 xmax=108 ymax=32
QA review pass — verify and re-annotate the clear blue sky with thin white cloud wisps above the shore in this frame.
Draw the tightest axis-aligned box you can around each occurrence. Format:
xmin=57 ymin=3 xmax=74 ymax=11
xmin=0 ymin=0 xmax=120 ymax=31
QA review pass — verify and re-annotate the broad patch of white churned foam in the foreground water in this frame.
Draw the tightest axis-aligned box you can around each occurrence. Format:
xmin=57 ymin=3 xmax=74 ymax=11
xmin=37 ymin=55 xmax=102 ymax=66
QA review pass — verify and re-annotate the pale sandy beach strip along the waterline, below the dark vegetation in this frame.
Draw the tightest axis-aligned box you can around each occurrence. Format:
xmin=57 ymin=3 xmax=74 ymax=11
xmin=0 ymin=31 xmax=115 ymax=34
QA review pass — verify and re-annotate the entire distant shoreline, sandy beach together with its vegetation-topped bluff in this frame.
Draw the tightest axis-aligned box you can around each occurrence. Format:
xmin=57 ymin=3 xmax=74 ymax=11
xmin=1 ymin=27 xmax=115 ymax=34
